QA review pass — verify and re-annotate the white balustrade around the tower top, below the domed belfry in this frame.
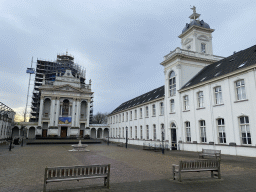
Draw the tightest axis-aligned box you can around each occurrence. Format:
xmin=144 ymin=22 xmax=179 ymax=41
xmin=164 ymin=47 xmax=224 ymax=61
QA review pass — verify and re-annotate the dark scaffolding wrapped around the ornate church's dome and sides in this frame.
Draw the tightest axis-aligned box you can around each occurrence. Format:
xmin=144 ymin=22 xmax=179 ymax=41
xmin=29 ymin=53 xmax=93 ymax=122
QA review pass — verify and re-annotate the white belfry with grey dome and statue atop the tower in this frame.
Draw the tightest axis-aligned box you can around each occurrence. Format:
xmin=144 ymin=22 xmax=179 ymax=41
xmin=179 ymin=6 xmax=214 ymax=55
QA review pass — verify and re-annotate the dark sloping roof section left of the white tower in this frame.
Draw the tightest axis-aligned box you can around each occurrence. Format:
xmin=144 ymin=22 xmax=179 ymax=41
xmin=110 ymin=85 xmax=164 ymax=115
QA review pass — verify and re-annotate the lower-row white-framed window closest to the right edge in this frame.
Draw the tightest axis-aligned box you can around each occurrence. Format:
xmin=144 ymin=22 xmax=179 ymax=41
xmin=239 ymin=116 xmax=252 ymax=144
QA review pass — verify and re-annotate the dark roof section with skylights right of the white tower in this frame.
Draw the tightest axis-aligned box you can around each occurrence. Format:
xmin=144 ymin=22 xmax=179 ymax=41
xmin=181 ymin=45 xmax=256 ymax=90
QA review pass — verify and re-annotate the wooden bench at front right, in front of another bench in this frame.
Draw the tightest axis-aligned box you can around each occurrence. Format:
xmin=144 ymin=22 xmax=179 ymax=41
xmin=173 ymin=160 xmax=221 ymax=182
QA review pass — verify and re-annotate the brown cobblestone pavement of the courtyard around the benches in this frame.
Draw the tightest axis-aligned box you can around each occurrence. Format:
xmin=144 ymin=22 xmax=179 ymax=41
xmin=0 ymin=144 xmax=256 ymax=192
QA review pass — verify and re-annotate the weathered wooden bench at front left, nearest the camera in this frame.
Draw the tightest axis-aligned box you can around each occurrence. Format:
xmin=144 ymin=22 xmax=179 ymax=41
xmin=43 ymin=164 xmax=110 ymax=192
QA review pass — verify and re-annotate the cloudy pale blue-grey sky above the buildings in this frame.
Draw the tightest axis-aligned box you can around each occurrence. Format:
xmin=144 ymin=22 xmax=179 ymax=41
xmin=0 ymin=0 xmax=256 ymax=120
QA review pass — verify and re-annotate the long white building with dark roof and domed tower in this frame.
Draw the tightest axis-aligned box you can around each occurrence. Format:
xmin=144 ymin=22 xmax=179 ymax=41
xmin=108 ymin=7 xmax=256 ymax=157
